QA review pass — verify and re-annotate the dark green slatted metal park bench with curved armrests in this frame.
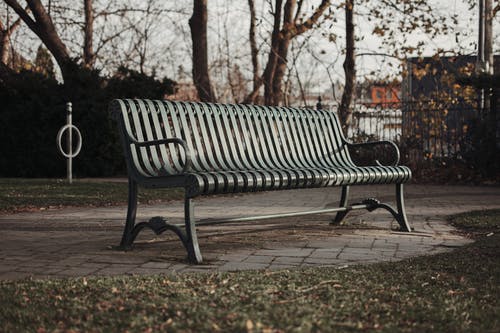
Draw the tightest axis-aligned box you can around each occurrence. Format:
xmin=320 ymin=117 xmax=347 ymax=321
xmin=110 ymin=99 xmax=411 ymax=263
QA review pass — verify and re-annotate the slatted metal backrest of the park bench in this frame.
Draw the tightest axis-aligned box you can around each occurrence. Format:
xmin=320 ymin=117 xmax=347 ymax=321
xmin=110 ymin=99 xmax=353 ymax=177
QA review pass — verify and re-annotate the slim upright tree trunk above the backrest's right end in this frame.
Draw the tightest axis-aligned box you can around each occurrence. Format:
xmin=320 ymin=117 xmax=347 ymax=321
xmin=339 ymin=0 xmax=356 ymax=128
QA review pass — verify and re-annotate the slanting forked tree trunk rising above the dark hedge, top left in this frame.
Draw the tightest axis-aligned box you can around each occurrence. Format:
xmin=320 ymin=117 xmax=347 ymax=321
xmin=4 ymin=0 xmax=78 ymax=83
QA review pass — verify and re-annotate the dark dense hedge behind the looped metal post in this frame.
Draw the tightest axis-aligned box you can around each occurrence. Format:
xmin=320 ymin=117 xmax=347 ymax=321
xmin=0 ymin=68 xmax=175 ymax=177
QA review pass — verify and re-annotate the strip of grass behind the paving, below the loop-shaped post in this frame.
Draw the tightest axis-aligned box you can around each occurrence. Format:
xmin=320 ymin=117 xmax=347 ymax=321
xmin=0 ymin=178 xmax=183 ymax=213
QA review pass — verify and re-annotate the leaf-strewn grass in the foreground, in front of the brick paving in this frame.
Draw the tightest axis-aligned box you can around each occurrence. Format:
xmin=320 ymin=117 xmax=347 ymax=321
xmin=0 ymin=210 xmax=500 ymax=332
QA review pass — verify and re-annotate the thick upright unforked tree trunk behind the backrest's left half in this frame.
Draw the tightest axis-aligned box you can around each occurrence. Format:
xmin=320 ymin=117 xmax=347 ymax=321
xmin=189 ymin=0 xmax=216 ymax=102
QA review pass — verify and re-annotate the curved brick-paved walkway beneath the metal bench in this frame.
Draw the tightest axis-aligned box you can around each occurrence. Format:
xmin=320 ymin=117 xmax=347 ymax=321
xmin=0 ymin=185 xmax=500 ymax=279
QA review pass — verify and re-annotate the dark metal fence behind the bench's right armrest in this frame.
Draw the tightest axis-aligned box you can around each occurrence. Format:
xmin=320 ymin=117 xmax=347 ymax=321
xmin=347 ymin=101 xmax=477 ymax=158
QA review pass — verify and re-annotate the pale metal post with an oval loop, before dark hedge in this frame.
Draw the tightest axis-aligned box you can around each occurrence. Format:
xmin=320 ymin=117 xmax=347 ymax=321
xmin=56 ymin=102 xmax=82 ymax=184
